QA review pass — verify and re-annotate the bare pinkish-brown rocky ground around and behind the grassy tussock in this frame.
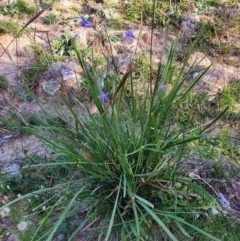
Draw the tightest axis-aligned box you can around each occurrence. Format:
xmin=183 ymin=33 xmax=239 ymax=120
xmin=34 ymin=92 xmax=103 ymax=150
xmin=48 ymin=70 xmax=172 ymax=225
xmin=0 ymin=0 xmax=240 ymax=241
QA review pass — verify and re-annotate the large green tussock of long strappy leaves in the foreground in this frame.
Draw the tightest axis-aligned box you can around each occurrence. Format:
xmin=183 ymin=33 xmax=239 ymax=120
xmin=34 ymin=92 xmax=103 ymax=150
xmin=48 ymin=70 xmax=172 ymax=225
xmin=0 ymin=40 xmax=227 ymax=241
